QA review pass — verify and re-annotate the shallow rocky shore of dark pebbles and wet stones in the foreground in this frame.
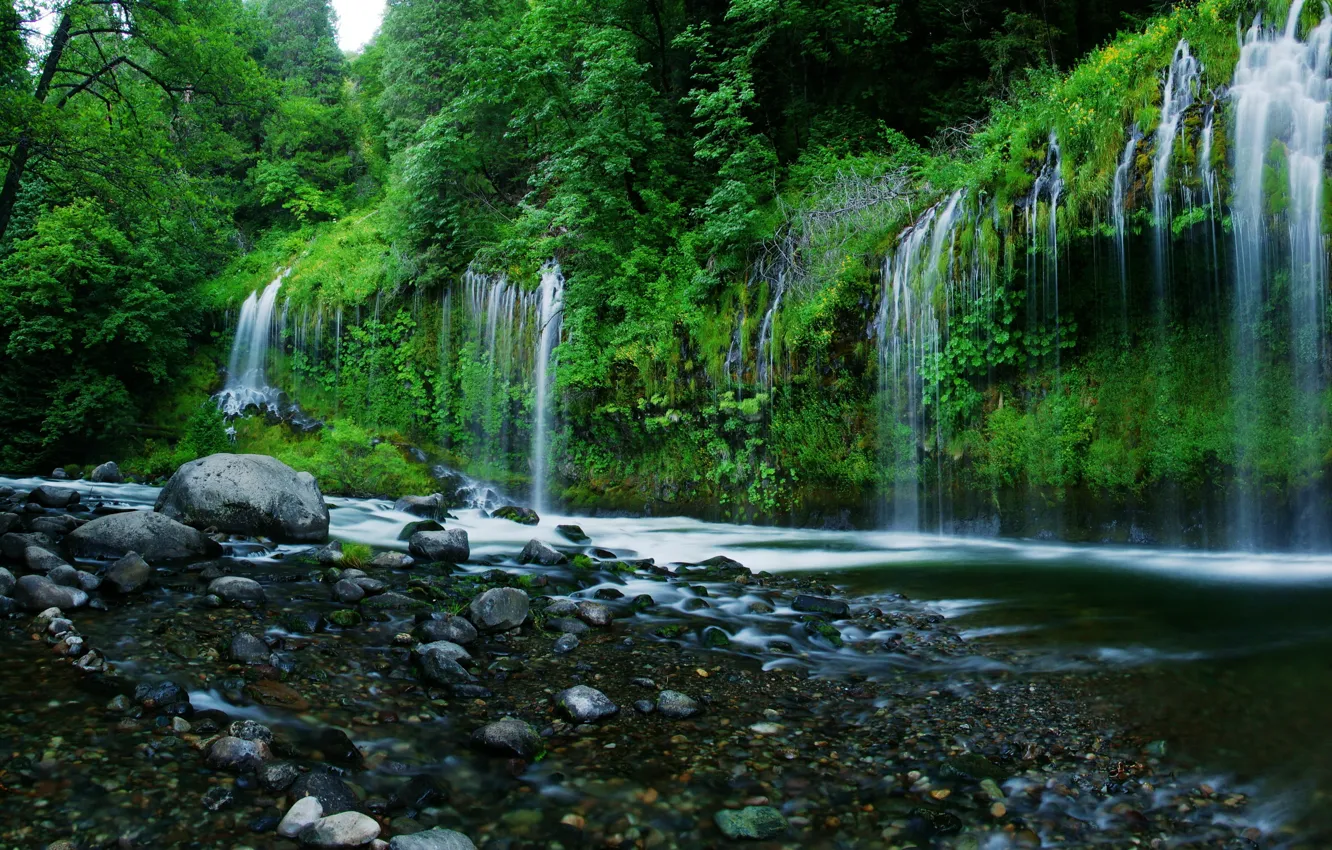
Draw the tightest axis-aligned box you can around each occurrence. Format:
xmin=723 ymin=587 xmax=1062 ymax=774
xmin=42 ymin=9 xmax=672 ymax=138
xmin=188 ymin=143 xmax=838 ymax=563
xmin=0 ymin=456 xmax=1294 ymax=850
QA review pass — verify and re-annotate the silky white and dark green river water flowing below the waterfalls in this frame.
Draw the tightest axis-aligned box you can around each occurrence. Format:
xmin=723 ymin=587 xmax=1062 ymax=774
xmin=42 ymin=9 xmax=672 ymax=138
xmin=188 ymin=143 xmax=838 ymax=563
xmin=0 ymin=478 xmax=1332 ymax=846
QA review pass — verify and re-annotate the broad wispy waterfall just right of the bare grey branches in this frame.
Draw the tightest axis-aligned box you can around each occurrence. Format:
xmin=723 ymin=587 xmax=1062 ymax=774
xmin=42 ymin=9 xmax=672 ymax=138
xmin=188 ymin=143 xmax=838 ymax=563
xmin=874 ymin=191 xmax=966 ymax=530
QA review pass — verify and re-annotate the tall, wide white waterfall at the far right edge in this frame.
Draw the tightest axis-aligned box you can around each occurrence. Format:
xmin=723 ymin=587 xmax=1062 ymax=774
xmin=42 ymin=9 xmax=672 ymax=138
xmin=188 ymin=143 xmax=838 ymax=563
xmin=1229 ymin=0 xmax=1332 ymax=548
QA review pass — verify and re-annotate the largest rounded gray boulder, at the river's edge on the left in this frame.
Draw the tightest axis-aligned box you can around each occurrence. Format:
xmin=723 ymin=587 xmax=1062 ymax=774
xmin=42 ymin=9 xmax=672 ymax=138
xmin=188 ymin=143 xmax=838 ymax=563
xmin=156 ymin=454 xmax=329 ymax=544
